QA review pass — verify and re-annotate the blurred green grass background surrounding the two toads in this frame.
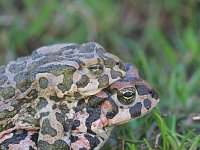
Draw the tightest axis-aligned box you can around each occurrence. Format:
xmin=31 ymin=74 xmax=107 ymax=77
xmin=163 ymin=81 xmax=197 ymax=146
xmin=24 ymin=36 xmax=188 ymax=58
xmin=0 ymin=0 xmax=200 ymax=150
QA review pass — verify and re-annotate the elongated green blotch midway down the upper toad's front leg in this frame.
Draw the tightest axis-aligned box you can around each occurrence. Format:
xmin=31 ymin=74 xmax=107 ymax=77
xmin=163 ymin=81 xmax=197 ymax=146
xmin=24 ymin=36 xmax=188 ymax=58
xmin=41 ymin=118 xmax=57 ymax=137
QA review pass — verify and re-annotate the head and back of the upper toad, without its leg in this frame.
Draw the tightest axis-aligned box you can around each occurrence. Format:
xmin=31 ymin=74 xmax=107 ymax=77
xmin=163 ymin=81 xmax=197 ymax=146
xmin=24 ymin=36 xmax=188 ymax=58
xmin=0 ymin=42 xmax=126 ymax=131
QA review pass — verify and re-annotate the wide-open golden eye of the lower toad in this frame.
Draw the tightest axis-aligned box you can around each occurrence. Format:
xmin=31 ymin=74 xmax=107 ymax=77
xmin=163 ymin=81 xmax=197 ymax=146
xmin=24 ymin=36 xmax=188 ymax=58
xmin=117 ymin=87 xmax=136 ymax=105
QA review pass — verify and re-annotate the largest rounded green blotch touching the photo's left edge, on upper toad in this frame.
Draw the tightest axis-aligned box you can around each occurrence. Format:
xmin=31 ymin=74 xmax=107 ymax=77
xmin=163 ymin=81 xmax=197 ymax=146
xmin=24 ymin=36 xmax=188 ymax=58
xmin=0 ymin=87 xmax=15 ymax=99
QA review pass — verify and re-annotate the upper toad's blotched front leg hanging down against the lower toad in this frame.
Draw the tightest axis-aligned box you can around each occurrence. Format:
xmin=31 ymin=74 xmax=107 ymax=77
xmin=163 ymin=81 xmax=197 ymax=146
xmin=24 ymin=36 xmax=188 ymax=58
xmin=37 ymin=99 xmax=75 ymax=150
